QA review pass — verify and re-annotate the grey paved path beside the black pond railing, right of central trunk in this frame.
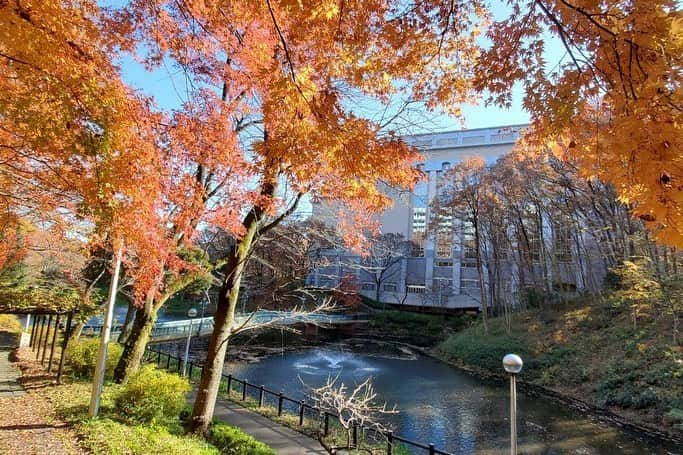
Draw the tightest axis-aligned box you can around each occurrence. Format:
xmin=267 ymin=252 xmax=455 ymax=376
xmin=213 ymin=401 xmax=327 ymax=455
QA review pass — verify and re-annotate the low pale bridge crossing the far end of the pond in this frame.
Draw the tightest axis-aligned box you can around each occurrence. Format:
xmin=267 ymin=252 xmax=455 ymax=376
xmin=83 ymin=310 xmax=368 ymax=343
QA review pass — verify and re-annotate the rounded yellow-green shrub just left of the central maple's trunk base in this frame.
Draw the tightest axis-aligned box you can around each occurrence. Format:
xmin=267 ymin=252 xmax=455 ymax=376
xmin=115 ymin=365 xmax=190 ymax=424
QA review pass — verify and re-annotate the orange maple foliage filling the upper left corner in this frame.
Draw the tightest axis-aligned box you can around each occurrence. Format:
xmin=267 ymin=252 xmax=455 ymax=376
xmin=0 ymin=0 xmax=166 ymax=278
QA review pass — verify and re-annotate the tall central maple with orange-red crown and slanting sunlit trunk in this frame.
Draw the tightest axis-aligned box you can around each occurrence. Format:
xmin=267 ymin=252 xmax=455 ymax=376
xmin=112 ymin=1 xmax=496 ymax=432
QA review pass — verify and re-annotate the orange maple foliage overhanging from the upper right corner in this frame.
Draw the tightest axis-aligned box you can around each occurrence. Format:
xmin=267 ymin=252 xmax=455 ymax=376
xmin=475 ymin=0 xmax=683 ymax=246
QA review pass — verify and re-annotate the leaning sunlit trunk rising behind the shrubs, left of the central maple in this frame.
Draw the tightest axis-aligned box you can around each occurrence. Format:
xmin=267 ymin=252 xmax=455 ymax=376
xmin=114 ymin=297 xmax=159 ymax=384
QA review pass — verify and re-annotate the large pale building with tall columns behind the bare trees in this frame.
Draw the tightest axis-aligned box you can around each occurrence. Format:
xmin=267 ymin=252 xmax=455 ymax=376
xmin=309 ymin=125 xmax=600 ymax=309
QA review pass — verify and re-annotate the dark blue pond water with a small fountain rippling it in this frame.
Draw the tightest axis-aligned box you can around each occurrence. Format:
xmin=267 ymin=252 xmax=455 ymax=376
xmin=225 ymin=342 xmax=681 ymax=455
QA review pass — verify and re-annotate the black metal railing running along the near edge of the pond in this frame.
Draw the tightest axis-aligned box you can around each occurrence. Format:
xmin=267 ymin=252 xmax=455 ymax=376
xmin=146 ymin=346 xmax=453 ymax=455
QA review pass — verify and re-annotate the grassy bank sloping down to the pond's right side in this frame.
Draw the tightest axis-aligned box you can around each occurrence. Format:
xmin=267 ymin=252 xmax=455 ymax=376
xmin=435 ymin=306 xmax=683 ymax=432
